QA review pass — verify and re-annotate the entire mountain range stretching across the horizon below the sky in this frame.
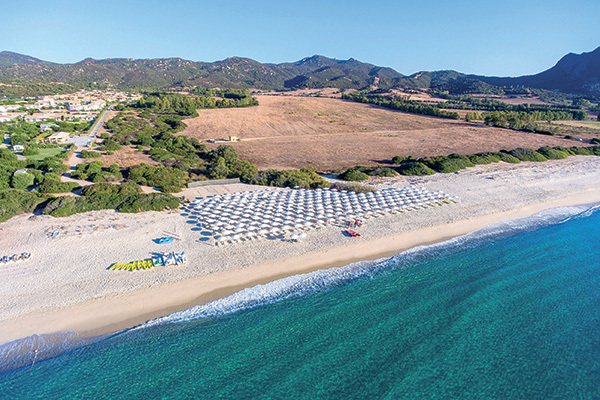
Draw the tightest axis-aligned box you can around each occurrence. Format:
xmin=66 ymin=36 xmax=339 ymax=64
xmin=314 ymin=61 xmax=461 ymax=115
xmin=0 ymin=47 xmax=600 ymax=98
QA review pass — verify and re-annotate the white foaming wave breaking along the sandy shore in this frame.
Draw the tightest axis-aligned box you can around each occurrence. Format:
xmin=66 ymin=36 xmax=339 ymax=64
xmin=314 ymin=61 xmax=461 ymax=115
xmin=130 ymin=205 xmax=600 ymax=331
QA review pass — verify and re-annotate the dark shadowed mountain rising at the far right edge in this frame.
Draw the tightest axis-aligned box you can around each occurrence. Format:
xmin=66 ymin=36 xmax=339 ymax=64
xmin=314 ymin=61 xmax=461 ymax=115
xmin=476 ymin=47 xmax=600 ymax=96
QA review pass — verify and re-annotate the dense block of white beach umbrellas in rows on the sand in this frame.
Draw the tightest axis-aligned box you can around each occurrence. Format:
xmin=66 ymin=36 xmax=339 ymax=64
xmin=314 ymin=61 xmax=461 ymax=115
xmin=191 ymin=186 xmax=455 ymax=245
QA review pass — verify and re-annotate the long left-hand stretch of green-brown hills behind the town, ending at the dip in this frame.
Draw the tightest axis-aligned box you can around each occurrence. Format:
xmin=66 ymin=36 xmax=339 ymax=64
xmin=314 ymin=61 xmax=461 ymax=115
xmin=0 ymin=52 xmax=403 ymax=90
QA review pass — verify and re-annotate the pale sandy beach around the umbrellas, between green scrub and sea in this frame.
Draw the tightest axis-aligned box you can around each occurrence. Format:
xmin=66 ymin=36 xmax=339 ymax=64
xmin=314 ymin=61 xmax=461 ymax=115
xmin=0 ymin=156 xmax=600 ymax=343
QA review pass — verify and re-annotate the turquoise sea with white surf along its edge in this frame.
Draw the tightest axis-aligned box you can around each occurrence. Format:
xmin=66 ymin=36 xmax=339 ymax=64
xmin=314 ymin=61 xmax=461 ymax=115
xmin=0 ymin=208 xmax=600 ymax=399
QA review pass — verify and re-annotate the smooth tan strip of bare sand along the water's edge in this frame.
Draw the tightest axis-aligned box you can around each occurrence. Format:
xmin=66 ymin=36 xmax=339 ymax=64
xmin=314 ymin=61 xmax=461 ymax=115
xmin=0 ymin=188 xmax=600 ymax=344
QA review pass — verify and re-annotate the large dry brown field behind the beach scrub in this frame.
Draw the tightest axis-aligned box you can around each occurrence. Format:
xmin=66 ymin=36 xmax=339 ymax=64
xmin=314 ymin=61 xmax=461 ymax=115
xmin=181 ymin=96 xmax=574 ymax=171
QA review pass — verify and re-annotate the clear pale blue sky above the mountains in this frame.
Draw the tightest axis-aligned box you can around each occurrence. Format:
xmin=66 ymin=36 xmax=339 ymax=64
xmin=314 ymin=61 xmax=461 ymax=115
xmin=0 ymin=0 xmax=600 ymax=76
